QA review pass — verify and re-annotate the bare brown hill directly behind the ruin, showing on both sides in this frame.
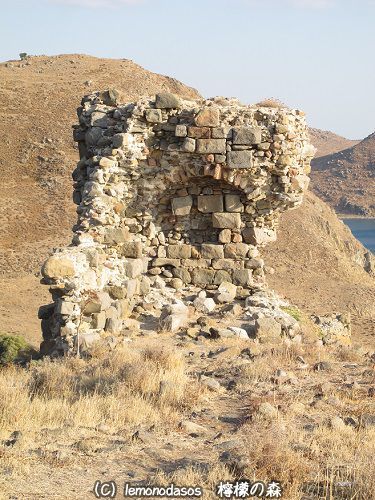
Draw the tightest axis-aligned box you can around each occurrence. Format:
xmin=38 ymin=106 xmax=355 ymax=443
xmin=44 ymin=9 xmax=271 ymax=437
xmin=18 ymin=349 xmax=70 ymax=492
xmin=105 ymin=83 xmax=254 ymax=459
xmin=0 ymin=55 xmax=375 ymax=343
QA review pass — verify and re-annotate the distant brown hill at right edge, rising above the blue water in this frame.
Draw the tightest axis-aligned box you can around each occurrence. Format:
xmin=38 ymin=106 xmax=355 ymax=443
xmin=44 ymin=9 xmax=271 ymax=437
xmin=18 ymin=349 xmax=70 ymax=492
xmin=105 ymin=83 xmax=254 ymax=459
xmin=312 ymin=133 xmax=375 ymax=216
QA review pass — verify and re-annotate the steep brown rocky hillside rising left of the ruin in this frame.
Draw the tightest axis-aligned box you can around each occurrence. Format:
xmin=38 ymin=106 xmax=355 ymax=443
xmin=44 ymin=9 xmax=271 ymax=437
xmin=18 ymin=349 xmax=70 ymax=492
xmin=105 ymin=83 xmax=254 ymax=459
xmin=0 ymin=54 xmax=198 ymax=276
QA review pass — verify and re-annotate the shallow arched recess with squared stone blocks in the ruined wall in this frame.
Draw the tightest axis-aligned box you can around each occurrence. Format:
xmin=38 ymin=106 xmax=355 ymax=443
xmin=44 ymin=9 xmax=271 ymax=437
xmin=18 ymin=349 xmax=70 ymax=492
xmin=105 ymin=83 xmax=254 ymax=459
xmin=144 ymin=176 xmax=263 ymax=289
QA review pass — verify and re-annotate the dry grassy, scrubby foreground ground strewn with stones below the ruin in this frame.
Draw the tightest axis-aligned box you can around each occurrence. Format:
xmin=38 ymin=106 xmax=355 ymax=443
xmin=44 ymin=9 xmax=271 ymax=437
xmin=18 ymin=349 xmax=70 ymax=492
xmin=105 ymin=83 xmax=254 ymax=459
xmin=0 ymin=336 xmax=375 ymax=500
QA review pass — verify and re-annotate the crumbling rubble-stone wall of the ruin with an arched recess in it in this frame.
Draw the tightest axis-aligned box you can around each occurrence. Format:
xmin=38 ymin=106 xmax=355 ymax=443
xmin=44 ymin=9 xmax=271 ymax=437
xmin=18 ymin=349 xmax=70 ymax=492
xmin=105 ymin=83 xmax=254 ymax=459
xmin=39 ymin=90 xmax=315 ymax=355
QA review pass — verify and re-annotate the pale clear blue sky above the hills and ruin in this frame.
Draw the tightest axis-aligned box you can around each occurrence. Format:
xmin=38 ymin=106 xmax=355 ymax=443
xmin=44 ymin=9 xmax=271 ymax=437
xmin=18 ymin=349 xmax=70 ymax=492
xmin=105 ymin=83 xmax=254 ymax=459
xmin=0 ymin=0 xmax=375 ymax=139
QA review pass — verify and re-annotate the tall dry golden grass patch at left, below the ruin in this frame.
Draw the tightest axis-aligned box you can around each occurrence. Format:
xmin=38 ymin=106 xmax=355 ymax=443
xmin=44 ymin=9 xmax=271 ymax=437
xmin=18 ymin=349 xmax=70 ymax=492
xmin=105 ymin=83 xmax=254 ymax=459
xmin=0 ymin=348 xmax=203 ymax=436
